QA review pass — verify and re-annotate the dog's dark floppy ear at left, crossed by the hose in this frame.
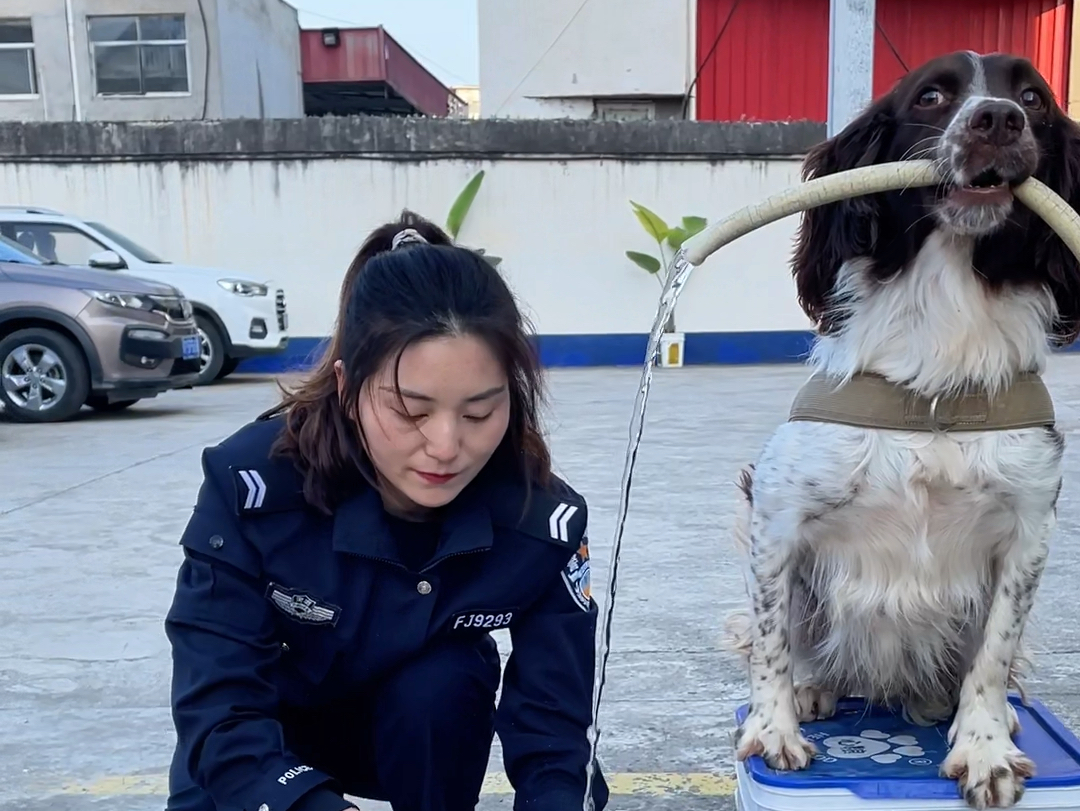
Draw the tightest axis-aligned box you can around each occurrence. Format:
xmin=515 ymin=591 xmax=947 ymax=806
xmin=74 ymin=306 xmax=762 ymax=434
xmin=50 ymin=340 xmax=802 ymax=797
xmin=792 ymin=96 xmax=894 ymax=333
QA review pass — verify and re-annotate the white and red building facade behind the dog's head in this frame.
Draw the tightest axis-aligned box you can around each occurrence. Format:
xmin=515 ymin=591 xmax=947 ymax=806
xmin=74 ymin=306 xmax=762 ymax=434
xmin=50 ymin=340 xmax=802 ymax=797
xmin=478 ymin=0 xmax=1080 ymax=122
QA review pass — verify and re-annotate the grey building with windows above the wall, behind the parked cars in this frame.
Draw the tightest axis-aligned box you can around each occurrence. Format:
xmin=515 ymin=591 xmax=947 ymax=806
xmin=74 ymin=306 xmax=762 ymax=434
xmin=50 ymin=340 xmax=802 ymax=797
xmin=0 ymin=0 xmax=303 ymax=121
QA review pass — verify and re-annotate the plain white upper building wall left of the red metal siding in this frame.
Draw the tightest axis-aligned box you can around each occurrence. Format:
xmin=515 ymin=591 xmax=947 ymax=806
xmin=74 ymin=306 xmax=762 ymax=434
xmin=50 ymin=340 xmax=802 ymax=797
xmin=478 ymin=0 xmax=694 ymax=118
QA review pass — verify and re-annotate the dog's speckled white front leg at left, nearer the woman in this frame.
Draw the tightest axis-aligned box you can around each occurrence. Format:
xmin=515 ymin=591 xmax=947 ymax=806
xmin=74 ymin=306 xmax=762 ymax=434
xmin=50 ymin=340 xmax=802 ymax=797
xmin=735 ymin=514 xmax=815 ymax=770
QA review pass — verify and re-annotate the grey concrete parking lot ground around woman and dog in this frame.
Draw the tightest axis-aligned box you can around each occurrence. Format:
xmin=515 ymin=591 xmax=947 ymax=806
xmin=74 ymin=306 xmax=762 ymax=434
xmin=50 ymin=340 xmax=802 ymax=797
xmin=6 ymin=356 xmax=1080 ymax=811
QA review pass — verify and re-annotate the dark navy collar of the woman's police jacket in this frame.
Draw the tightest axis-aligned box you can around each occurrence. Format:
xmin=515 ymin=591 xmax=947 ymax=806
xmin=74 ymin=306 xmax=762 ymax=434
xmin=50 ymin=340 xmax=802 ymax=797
xmin=333 ymin=487 xmax=495 ymax=568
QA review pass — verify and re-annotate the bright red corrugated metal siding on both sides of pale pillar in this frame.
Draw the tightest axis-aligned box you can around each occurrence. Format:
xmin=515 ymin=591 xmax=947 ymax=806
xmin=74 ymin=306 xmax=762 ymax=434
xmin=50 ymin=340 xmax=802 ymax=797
xmin=697 ymin=0 xmax=1072 ymax=121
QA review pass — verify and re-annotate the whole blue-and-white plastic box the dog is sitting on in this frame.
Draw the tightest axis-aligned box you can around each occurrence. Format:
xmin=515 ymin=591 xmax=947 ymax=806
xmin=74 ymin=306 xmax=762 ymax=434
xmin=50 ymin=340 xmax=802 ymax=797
xmin=735 ymin=697 xmax=1080 ymax=811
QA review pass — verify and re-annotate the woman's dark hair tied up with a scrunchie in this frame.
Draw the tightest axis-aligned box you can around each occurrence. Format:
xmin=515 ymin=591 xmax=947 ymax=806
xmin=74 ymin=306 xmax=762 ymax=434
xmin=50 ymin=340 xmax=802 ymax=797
xmin=264 ymin=211 xmax=551 ymax=513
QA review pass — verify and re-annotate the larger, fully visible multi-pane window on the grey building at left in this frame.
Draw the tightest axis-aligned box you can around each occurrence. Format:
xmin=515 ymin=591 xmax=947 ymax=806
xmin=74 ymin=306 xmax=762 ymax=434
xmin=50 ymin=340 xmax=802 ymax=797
xmin=87 ymin=14 xmax=189 ymax=96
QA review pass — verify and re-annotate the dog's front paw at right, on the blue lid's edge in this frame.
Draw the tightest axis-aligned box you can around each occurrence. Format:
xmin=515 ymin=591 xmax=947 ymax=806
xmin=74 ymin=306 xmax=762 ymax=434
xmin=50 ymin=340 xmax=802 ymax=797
xmin=942 ymin=732 xmax=1035 ymax=810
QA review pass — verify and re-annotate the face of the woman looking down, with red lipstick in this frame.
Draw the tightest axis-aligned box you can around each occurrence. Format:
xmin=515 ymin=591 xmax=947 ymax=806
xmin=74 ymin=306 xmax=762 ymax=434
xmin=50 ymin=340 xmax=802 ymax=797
xmin=337 ymin=336 xmax=510 ymax=512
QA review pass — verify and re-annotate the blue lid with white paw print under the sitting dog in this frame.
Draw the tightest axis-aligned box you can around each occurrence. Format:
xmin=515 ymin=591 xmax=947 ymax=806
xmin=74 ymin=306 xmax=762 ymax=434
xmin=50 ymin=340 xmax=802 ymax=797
xmin=735 ymin=697 xmax=1080 ymax=799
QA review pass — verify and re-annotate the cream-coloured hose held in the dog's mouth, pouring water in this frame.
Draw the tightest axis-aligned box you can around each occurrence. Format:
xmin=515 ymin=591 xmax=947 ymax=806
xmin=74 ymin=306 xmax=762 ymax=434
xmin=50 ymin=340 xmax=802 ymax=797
xmin=683 ymin=161 xmax=1080 ymax=267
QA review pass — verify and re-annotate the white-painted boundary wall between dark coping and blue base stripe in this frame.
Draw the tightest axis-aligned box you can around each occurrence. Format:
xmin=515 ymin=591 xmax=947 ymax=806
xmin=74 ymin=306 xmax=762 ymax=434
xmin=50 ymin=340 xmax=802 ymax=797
xmin=0 ymin=159 xmax=809 ymax=337
